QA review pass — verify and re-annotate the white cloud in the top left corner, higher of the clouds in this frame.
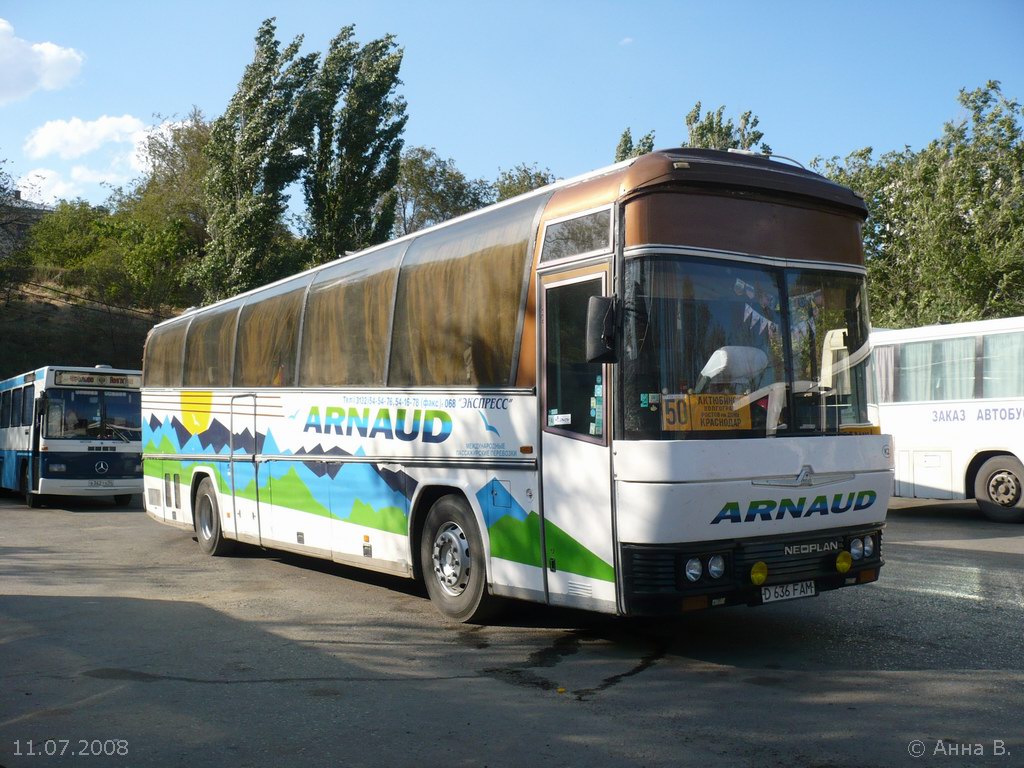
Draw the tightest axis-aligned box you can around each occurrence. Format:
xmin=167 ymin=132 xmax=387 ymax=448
xmin=0 ymin=18 xmax=85 ymax=106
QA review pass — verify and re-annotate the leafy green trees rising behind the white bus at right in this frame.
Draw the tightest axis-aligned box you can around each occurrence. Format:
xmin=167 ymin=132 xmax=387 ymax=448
xmin=814 ymin=81 xmax=1024 ymax=328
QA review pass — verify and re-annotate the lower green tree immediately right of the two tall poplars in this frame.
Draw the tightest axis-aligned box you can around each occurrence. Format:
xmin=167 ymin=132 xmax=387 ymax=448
xmin=394 ymin=146 xmax=495 ymax=237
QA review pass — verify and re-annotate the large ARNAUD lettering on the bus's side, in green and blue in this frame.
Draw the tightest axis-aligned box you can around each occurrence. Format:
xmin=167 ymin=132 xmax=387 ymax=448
xmin=302 ymin=406 xmax=452 ymax=442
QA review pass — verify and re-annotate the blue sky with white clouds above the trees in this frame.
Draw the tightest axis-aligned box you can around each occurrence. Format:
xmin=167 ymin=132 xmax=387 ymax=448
xmin=0 ymin=0 xmax=1024 ymax=203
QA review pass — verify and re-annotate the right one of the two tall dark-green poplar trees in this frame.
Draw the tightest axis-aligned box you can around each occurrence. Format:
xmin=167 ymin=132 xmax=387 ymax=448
xmin=303 ymin=27 xmax=408 ymax=263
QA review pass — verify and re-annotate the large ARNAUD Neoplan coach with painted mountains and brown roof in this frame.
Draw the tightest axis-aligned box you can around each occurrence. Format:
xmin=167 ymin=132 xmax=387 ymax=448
xmin=142 ymin=150 xmax=892 ymax=621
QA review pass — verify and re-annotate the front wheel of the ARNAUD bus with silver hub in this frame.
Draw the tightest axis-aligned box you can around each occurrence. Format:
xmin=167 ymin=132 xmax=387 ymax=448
xmin=420 ymin=496 xmax=497 ymax=624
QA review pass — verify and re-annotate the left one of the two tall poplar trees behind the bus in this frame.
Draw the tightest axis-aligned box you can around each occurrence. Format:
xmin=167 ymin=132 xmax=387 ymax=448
xmin=195 ymin=18 xmax=318 ymax=300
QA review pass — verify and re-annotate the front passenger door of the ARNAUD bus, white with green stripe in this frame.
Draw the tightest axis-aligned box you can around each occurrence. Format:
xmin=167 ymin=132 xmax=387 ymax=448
xmin=541 ymin=265 xmax=616 ymax=612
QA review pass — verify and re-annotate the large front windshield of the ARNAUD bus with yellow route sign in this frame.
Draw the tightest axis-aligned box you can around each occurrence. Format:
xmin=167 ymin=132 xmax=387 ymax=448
xmin=623 ymin=256 xmax=869 ymax=439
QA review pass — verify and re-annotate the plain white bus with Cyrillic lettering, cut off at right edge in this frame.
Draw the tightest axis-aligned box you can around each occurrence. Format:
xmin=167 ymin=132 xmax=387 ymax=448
xmin=871 ymin=317 xmax=1024 ymax=522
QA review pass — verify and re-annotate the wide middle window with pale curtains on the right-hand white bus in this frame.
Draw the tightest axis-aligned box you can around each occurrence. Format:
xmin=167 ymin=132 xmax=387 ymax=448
xmin=897 ymin=336 xmax=975 ymax=402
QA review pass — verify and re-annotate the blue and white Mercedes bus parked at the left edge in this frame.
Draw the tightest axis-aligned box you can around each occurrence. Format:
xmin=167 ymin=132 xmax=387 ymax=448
xmin=0 ymin=366 xmax=142 ymax=507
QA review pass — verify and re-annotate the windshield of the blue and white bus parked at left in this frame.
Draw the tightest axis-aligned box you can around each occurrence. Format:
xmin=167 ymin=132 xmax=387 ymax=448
xmin=43 ymin=389 xmax=142 ymax=442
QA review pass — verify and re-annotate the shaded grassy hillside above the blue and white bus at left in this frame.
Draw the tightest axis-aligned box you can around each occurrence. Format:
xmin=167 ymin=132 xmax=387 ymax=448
xmin=0 ymin=292 xmax=157 ymax=379
